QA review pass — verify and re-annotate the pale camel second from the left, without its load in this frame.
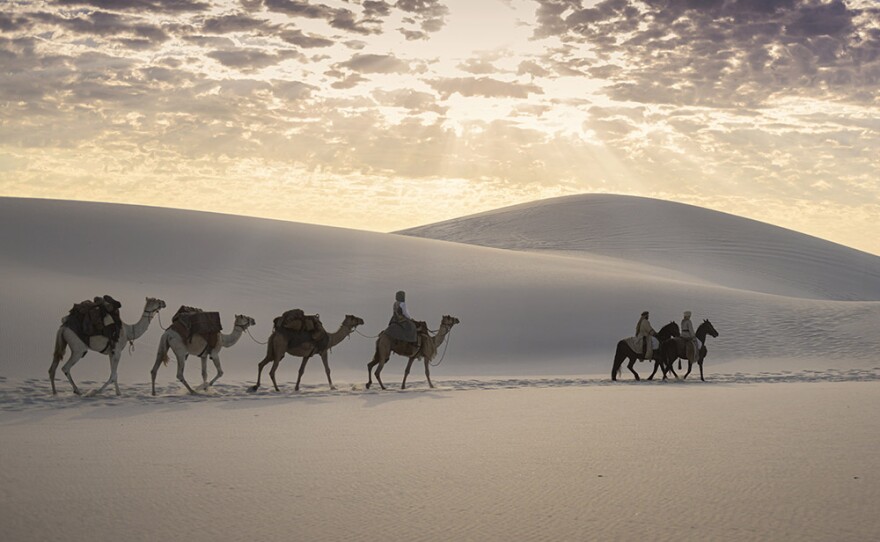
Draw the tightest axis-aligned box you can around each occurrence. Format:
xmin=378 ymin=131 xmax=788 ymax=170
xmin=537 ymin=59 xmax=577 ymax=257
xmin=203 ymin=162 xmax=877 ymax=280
xmin=150 ymin=314 xmax=256 ymax=395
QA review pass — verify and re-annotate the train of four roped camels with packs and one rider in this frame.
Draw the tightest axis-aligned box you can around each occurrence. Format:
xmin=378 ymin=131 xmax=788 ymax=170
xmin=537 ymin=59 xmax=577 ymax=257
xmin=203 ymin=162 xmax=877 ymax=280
xmin=49 ymin=292 xmax=459 ymax=395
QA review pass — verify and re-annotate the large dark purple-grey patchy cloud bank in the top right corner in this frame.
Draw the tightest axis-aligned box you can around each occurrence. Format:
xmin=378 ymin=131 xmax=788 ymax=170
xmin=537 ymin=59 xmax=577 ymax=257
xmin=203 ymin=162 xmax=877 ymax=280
xmin=536 ymin=0 xmax=880 ymax=106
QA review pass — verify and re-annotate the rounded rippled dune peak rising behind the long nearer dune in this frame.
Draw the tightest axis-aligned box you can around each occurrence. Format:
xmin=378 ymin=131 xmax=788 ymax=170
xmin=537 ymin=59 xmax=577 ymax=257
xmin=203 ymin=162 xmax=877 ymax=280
xmin=398 ymin=194 xmax=880 ymax=301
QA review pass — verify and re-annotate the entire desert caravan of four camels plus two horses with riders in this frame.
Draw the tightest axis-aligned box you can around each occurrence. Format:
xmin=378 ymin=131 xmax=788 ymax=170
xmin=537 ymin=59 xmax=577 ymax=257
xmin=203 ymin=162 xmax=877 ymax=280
xmin=49 ymin=291 xmax=718 ymax=395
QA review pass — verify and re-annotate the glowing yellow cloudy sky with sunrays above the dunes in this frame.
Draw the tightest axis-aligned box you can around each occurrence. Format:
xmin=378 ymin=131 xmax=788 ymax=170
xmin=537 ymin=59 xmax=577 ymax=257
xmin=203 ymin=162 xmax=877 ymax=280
xmin=0 ymin=0 xmax=880 ymax=254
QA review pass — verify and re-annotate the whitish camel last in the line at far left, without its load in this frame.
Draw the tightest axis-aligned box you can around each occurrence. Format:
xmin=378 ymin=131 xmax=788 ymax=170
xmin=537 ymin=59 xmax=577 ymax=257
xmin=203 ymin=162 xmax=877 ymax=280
xmin=49 ymin=297 xmax=165 ymax=395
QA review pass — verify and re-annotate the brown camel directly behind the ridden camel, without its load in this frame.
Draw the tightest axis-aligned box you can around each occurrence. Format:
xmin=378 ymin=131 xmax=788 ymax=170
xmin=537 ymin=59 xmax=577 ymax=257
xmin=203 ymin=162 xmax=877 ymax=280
xmin=250 ymin=314 xmax=364 ymax=391
